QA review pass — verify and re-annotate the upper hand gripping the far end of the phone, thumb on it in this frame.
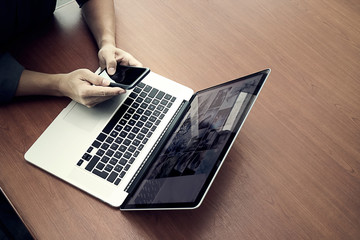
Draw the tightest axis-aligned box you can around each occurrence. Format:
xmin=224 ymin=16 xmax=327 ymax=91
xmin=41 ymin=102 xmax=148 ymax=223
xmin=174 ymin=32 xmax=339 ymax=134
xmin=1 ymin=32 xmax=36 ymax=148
xmin=98 ymin=44 xmax=142 ymax=75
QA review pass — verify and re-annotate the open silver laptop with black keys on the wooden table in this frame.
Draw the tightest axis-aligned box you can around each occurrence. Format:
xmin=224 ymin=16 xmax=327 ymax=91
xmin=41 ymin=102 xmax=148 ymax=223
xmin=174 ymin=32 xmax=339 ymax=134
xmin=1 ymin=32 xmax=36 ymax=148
xmin=25 ymin=69 xmax=270 ymax=210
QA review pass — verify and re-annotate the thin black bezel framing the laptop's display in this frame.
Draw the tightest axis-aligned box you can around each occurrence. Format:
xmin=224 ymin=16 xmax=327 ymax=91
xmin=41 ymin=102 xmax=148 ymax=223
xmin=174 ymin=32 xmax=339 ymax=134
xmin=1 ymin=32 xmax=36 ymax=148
xmin=120 ymin=69 xmax=270 ymax=210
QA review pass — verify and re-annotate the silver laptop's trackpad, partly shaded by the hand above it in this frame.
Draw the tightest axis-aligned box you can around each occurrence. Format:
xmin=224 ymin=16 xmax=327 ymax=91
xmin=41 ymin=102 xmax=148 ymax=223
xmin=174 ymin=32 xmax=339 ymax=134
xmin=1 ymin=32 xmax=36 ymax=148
xmin=64 ymin=99 xmax=115 ymax=131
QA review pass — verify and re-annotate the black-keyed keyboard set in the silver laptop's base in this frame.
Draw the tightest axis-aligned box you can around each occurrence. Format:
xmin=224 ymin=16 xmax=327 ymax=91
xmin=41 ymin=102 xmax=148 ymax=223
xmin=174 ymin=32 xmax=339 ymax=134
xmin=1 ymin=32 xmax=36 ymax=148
xmin=77 ymin=83 xmax=176 ymax=185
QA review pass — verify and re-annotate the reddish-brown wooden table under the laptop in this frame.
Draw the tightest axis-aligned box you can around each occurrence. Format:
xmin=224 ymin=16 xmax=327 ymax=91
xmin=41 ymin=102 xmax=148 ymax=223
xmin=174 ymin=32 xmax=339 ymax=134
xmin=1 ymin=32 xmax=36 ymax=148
xmin=0 ymin=0 xmax=360 ymax=239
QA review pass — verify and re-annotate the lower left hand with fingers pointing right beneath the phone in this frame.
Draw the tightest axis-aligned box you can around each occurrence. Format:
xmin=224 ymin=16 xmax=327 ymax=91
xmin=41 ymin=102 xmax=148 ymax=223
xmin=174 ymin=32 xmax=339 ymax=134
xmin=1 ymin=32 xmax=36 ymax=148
xmin=59 ymin=69 xmax=125 ymax=108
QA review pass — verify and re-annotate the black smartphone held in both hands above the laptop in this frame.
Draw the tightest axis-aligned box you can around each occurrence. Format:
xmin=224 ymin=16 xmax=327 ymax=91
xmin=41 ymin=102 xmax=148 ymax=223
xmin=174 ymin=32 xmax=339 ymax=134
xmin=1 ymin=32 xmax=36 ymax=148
xmin=99 ymin=64 xmax=150 ymax=89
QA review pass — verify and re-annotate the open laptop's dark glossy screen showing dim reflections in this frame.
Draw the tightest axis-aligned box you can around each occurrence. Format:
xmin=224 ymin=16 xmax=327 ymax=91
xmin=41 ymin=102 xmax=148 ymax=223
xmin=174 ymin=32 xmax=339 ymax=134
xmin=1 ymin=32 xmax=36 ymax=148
xmin=123 ymin=70 xmax=268 ymax=209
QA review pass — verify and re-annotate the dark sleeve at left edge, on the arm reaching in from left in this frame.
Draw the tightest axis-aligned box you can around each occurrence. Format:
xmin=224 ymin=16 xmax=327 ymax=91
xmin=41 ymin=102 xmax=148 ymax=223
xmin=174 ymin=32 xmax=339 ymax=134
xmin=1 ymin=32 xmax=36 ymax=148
xmin=0 ymin=53 xmax=24 ymax=103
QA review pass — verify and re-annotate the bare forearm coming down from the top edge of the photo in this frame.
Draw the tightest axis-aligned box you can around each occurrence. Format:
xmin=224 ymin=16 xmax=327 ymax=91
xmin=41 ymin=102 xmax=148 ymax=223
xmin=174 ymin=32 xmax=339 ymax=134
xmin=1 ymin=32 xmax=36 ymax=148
xmin=82 ymin=0 xmax=115 ymax=49
